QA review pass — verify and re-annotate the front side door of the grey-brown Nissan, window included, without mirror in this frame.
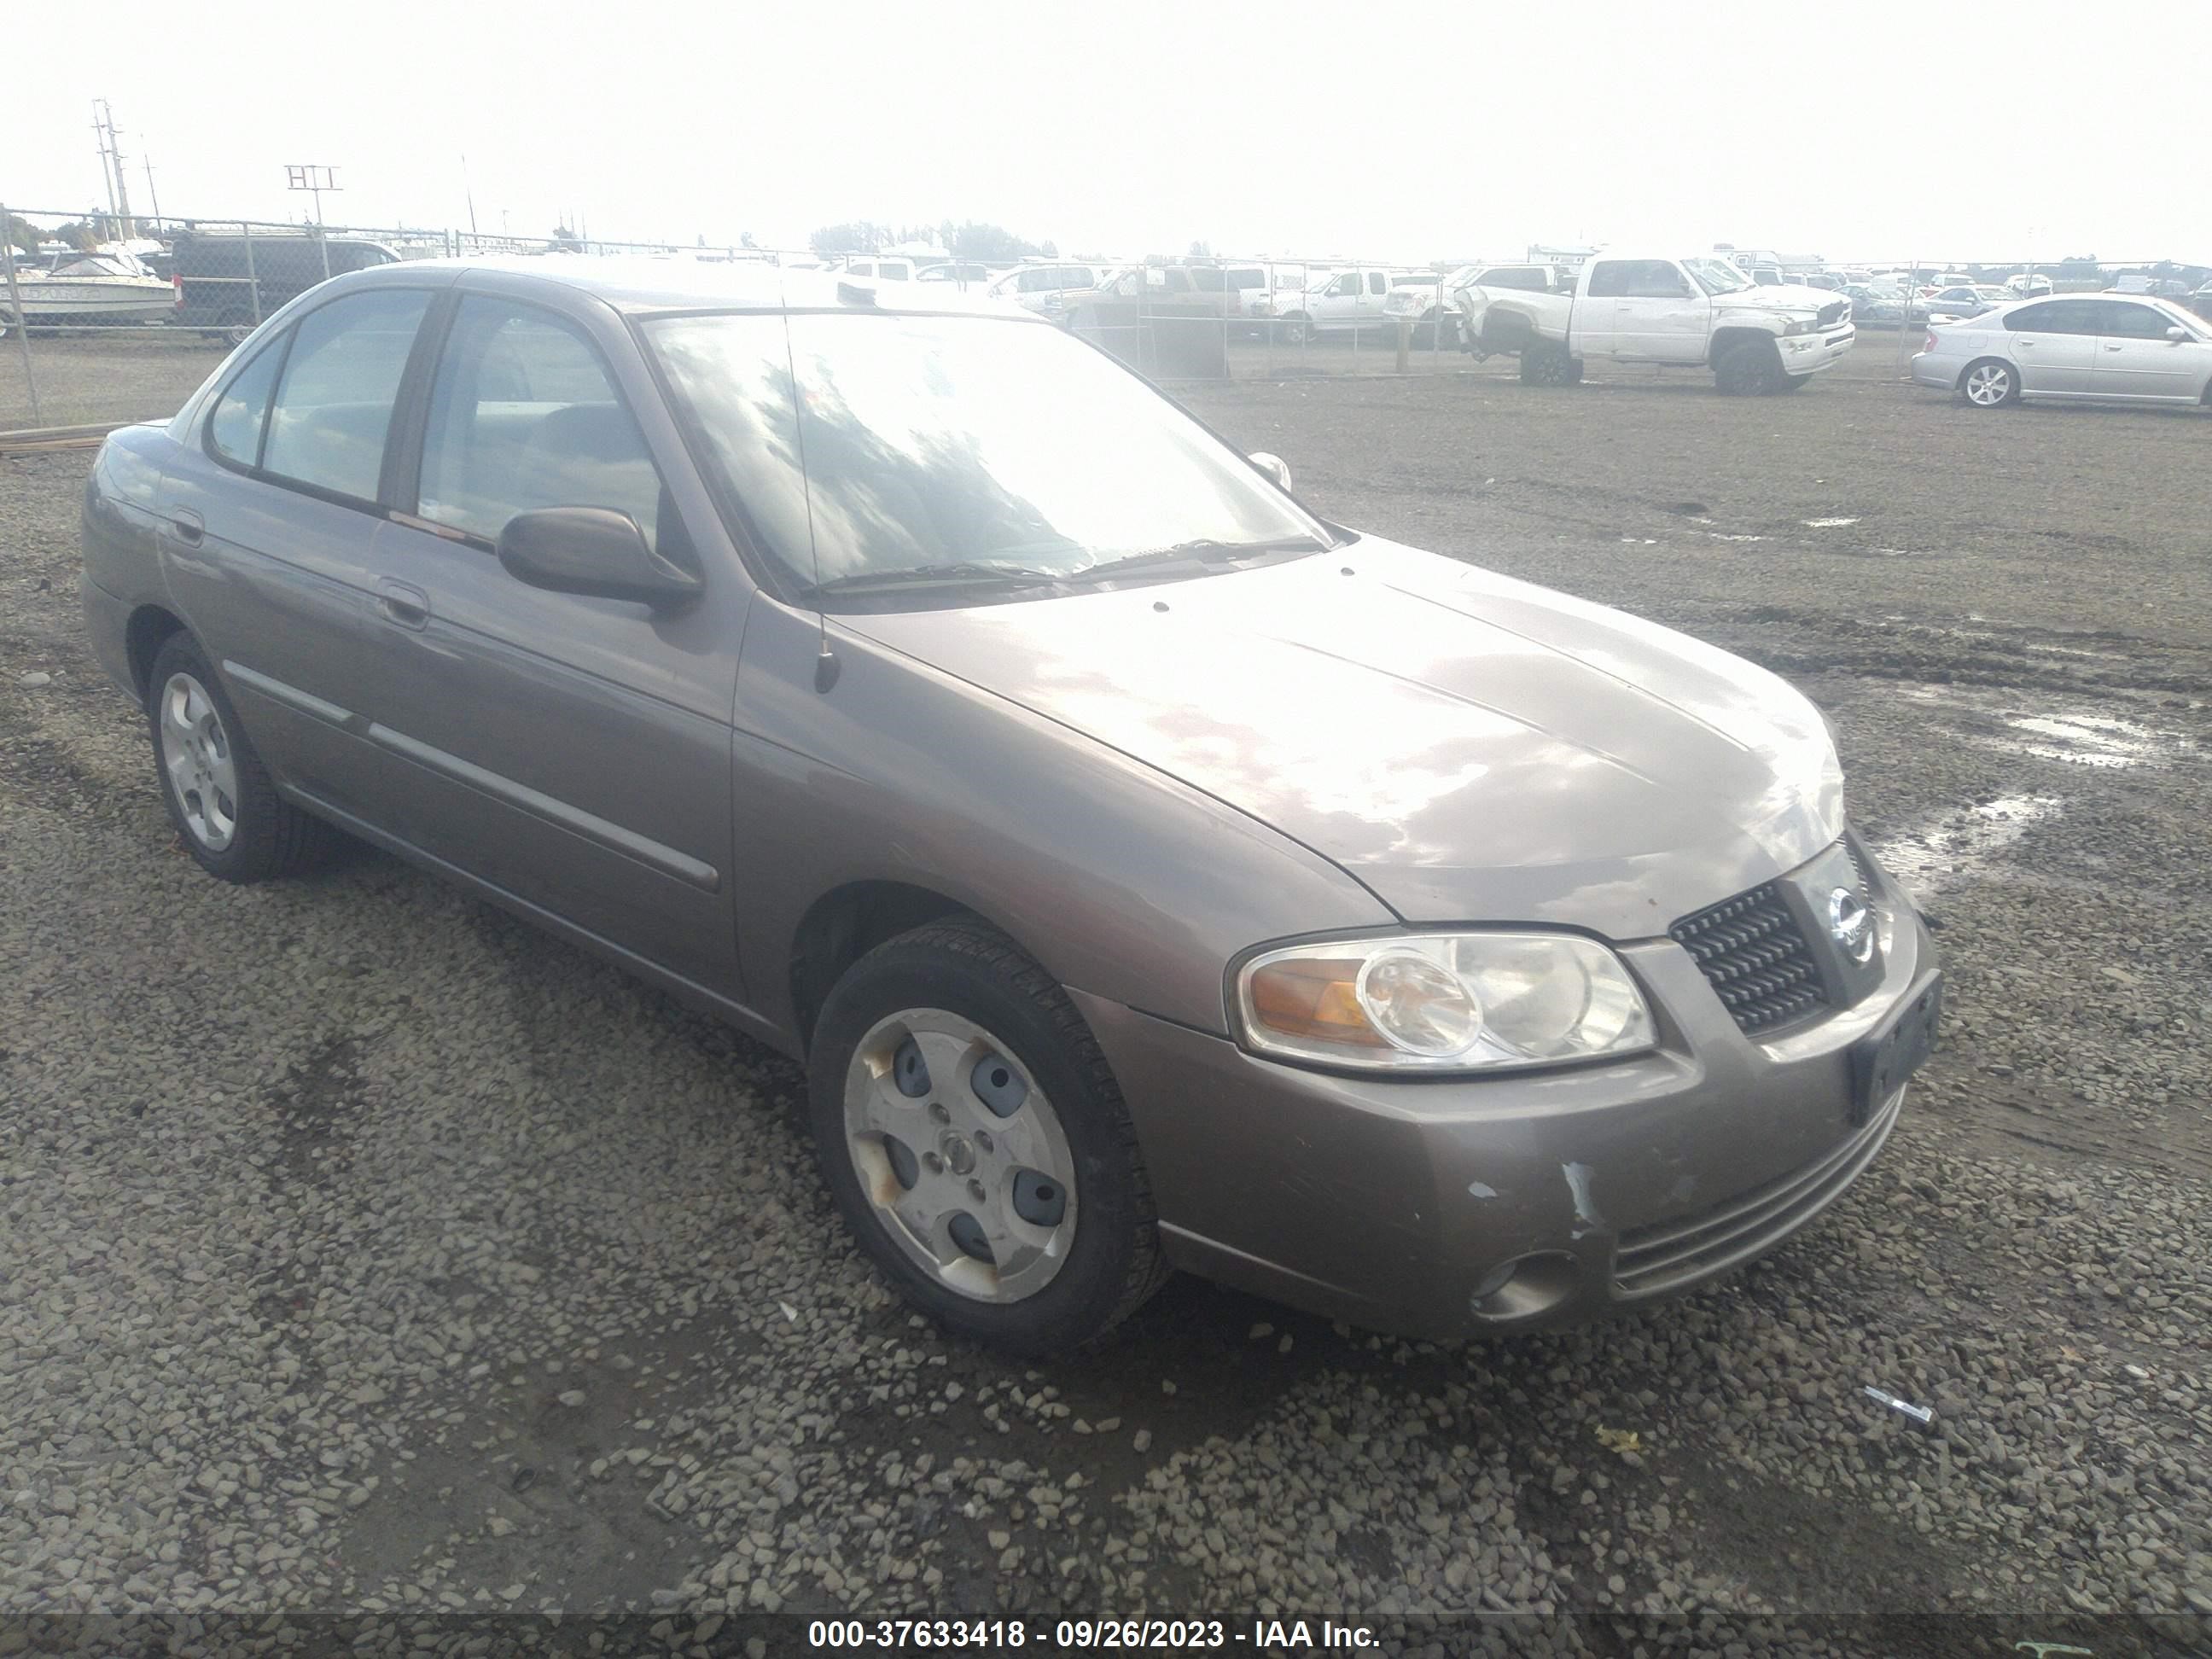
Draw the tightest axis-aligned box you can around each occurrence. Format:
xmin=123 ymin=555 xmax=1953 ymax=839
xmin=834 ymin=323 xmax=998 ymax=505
xmin=358 ymin=294 xmax=750 ymax=991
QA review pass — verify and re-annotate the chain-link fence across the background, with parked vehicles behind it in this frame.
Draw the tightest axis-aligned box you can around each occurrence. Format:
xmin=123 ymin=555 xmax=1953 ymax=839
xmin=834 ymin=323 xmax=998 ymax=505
xmin=0 ymin=195 xmax=2212 ymax=431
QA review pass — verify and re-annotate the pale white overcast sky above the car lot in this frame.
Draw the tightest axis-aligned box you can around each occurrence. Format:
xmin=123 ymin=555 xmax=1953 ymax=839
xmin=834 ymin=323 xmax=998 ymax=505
xmin=13 ymin=0 xmax=2212 ymax=263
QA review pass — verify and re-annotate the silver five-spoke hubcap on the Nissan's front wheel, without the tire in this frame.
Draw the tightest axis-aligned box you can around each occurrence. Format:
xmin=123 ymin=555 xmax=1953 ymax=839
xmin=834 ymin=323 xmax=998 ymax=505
xmin=845 ymin=1009 xmax=1077 ymax=1303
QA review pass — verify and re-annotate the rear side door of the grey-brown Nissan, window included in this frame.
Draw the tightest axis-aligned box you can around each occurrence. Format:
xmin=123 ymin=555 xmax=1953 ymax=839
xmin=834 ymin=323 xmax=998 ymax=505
xmin=157 ymin=288 xmax=434 ymax=823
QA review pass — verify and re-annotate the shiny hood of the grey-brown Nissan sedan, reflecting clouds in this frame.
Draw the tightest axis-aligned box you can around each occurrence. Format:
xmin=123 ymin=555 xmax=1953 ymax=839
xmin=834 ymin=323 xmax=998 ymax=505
xmin=838 ymin=538 xmax=1842 ymax=940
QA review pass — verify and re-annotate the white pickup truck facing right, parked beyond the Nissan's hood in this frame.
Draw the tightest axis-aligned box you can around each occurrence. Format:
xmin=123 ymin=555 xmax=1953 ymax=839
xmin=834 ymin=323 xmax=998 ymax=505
xmin=1453 ymin=252 xmax=1856 ymax=393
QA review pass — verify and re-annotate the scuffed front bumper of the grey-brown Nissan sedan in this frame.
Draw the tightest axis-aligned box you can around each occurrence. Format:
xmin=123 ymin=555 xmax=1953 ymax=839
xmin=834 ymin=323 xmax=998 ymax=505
xmin=1073 ymin=849 xmax=1936 ymax=1338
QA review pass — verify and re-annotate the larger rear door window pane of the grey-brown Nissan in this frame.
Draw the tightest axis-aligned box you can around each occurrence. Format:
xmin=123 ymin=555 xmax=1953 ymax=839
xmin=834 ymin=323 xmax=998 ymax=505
xmin=261 ymin=288 xmax=429 ymax=502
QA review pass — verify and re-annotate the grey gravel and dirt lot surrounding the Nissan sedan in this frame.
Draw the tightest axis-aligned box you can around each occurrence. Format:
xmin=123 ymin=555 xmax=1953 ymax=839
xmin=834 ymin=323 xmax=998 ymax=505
xmin=0 ymin=336 xmax=2212 ymax=1652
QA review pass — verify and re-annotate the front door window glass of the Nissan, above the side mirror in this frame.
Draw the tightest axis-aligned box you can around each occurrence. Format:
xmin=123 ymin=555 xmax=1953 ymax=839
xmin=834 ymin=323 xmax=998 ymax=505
xmin=416 ymin=294 xmax=664 ymax=546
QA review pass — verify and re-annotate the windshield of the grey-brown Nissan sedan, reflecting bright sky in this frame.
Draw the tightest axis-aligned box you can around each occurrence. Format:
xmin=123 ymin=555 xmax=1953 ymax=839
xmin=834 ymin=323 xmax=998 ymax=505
xmin=646 ymin=311 xmax=1334 ymax=608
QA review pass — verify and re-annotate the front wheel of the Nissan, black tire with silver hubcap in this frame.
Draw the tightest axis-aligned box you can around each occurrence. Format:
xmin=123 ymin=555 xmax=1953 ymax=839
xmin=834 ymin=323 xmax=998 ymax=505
xmin=807 ymin=920 xmax=1168 ymax=1356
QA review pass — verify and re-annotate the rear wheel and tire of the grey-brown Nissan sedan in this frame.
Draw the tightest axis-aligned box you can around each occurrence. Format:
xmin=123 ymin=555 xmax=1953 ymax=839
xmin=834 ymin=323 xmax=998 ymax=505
xmin=146 ymin=632 xmax=339 ymax=885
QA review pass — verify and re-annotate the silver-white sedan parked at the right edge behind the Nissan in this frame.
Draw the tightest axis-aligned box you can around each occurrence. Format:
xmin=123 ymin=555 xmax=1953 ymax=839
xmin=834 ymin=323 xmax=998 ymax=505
xmin=1913 ymin=294 xmax=2212 ymax=410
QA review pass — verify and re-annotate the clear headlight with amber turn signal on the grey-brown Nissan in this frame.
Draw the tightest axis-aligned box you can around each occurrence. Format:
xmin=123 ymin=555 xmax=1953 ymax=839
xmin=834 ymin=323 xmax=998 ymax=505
xmin=1237 ymin=934 xmax=1652 ymax=1073
